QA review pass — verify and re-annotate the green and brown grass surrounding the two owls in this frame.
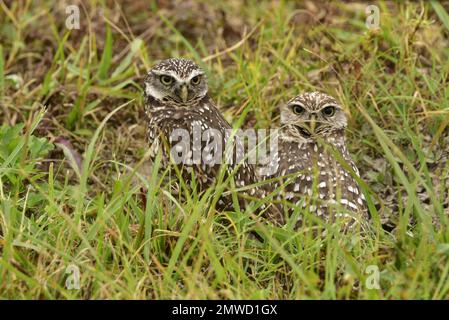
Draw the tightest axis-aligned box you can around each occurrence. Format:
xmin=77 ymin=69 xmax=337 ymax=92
xmin=0 ymin=1 xmax=449 ymax=299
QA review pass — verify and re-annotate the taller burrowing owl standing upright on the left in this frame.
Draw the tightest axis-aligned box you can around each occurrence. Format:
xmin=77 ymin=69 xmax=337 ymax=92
xmin=144 ymin=58 xmax=270 ymax=212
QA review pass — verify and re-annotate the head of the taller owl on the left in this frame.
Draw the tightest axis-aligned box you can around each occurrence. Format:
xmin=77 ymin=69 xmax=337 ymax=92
xmin=144 ymin=58 xmax=207 ymax=106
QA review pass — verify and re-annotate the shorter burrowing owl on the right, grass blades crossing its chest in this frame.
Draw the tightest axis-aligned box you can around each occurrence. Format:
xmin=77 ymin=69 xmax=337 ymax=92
xmin=266 ymin=92 xmax=369 ymax=229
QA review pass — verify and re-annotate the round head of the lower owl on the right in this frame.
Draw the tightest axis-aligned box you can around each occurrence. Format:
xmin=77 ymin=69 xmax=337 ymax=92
xmin=281 ymin=92 xmax=347 ymax=140
